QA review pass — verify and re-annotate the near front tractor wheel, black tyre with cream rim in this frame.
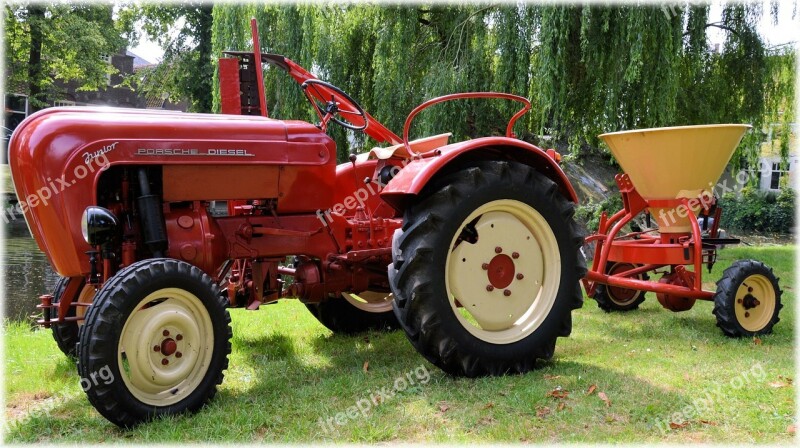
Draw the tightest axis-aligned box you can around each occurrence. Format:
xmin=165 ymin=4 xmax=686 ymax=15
xmin=78 ymin=259 xmax=231 ymax=427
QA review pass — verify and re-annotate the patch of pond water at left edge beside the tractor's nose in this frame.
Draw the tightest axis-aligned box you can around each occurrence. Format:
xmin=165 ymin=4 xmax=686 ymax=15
xmin=2 ymin=220 xmax=58 ymax=320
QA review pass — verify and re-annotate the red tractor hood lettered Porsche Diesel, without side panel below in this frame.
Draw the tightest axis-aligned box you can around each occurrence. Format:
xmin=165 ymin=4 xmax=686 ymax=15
xmin=8 ymin=107 xmax=336 ymax=275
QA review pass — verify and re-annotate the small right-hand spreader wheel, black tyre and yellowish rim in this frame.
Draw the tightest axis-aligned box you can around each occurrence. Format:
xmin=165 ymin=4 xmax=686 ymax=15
xmin=714 ymin=260 xmax=783 ymax=337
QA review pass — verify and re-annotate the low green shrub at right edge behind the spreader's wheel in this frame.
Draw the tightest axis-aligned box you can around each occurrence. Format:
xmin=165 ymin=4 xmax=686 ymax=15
xmin=720 ymin=187 xmax=796 ymax=234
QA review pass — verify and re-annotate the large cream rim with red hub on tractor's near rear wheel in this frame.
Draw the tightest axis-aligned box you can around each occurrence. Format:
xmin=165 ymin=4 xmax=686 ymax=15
xmin=445 ymin=199 xmax=561 ymax=344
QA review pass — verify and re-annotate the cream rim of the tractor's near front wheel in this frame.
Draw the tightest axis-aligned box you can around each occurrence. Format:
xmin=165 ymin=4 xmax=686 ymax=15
xmin=117 ymin=288 xmax=214 ymax=406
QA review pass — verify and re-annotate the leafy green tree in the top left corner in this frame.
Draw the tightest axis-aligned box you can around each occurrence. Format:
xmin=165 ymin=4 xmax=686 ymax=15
xmin=3 ymin=3 xmax=125 ymax=110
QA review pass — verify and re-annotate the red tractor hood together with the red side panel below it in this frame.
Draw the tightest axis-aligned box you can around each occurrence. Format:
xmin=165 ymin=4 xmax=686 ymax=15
xmin=9 ymin=107 xmax=336 ymax=276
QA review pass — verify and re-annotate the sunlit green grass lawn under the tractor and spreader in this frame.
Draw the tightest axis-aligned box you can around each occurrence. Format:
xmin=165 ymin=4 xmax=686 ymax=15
xmin=5 ymin=246 xmax=795 ymax=443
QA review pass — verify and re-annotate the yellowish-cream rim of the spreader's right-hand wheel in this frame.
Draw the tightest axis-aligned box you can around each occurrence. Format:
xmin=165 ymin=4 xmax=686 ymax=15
xmin=734 ymin=274 xmax=775 ymax=332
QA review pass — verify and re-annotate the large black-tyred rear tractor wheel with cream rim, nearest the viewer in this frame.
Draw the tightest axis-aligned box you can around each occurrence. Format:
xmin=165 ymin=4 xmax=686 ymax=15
xmin=389 ymin=162 xmax=586 ymax=377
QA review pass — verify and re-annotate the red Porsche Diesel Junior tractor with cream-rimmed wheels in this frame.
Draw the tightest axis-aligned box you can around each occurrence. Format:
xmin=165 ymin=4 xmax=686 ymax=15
xmin=10 ymin=24 xmax=586 ymax=427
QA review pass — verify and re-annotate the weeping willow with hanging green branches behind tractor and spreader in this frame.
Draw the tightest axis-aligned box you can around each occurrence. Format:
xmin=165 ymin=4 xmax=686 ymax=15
xmin=213 ymin=2 xmax=796 ymax=165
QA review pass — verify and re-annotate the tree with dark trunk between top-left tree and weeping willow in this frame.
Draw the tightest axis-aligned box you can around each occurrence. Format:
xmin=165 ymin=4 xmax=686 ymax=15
xmin=119 ymin=1 xmax=214 ymax=112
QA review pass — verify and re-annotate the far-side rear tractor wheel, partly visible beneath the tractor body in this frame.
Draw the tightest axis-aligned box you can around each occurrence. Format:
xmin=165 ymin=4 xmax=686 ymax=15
xmin=306 ymin=291 xmax=399 ymax=334
